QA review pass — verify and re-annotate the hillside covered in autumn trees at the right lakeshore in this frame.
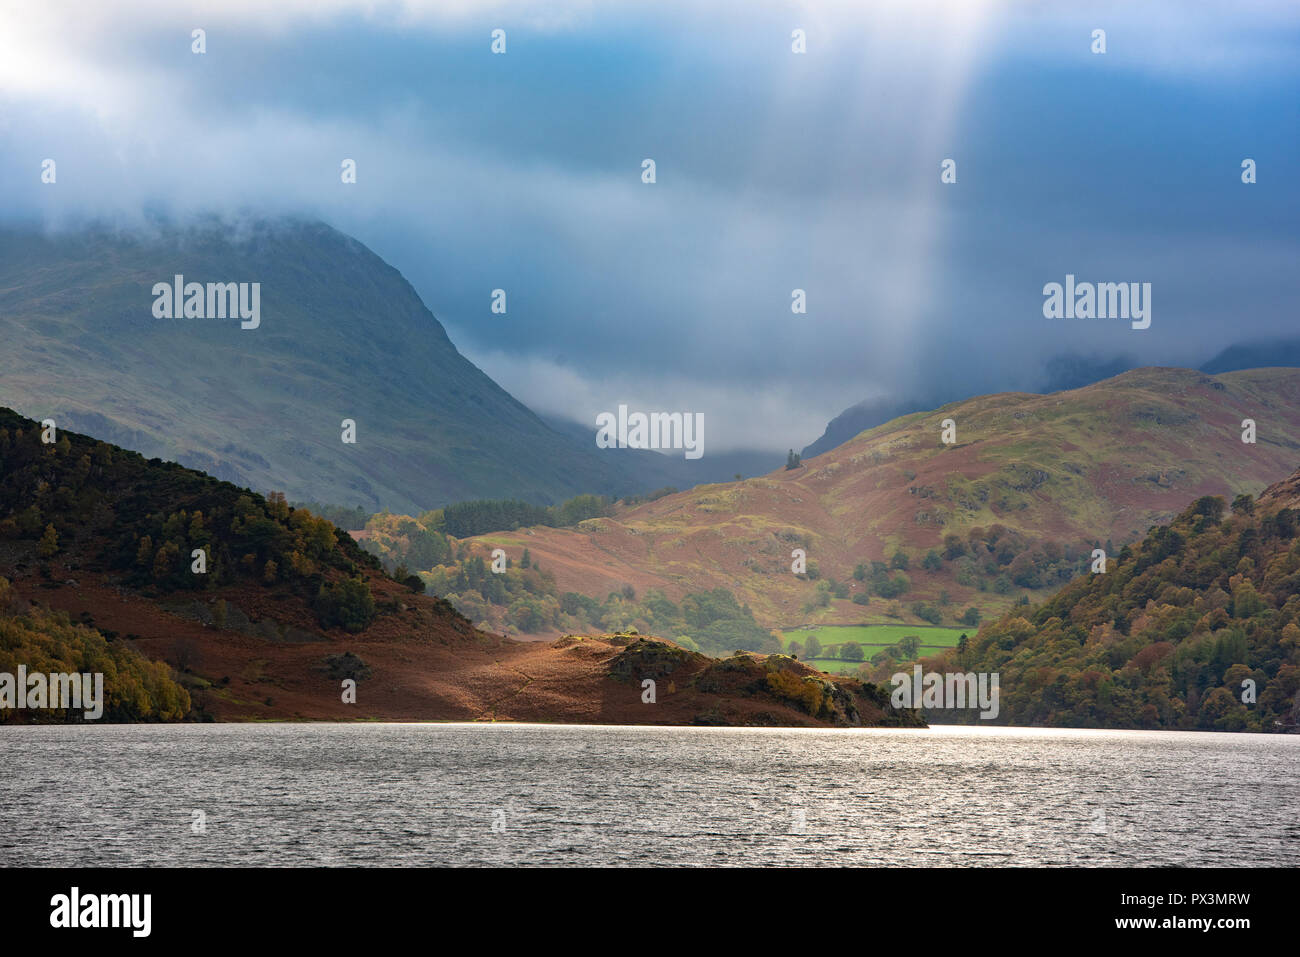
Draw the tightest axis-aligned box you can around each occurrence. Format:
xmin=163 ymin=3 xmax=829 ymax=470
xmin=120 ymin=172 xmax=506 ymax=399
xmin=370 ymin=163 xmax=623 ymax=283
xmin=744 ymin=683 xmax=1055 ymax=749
xmin=928 ymin=472 xmax=1300 ymax=732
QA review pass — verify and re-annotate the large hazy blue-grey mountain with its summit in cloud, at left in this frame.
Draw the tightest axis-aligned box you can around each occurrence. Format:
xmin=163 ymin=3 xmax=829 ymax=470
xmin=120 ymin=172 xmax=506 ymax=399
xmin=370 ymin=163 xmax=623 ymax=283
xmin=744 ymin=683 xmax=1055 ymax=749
xmin=0 ymin=220 xmax=657 ymax=511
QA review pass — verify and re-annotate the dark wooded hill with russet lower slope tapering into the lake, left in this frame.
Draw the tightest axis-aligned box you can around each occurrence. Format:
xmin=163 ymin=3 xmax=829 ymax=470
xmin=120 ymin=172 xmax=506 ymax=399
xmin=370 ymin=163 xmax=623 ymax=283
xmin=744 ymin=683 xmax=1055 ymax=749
xmin=0 ymin=408 xmax=920 ymax=727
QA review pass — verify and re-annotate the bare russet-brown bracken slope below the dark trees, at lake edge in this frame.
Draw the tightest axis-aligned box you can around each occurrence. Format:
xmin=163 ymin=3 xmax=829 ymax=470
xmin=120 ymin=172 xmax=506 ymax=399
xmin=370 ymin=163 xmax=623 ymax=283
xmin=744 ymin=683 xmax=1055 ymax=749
xmin=2 ymin=561 xmax=922 ymax=727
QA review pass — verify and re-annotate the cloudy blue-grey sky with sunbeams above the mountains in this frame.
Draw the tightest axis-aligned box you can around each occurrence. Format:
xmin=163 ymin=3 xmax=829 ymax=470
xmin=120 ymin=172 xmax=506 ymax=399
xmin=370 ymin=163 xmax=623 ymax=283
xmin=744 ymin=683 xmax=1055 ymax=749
xmin=0 ymin=0 xmax=1300 ymax=451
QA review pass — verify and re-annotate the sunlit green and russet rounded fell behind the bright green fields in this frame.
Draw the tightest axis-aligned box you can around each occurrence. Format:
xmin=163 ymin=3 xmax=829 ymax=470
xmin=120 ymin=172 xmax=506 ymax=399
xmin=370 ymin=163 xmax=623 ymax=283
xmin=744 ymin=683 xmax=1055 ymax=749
xmin=457 ymin=368 xmax=1300 ymax=628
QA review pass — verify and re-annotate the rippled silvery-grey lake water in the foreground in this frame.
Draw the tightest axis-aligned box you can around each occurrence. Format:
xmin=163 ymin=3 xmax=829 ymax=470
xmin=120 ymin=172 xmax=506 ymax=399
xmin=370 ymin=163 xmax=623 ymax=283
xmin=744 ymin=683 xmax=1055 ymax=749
xmin=0 ymin=724 xmax=1300 ymax=866
